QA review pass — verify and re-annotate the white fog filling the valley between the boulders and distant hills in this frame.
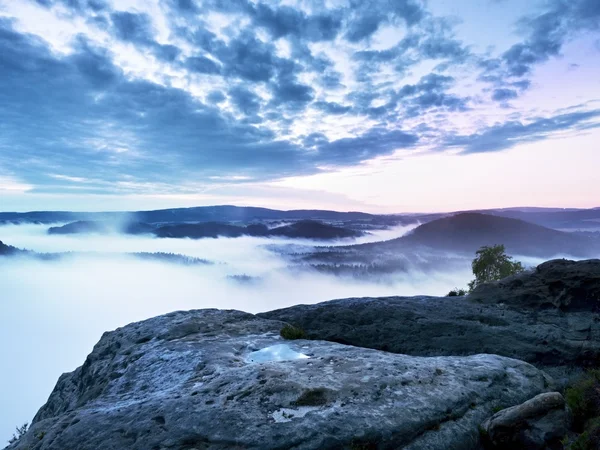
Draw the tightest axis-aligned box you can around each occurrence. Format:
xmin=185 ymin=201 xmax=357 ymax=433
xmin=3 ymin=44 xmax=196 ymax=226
xmin=0 ymin=225 xmax=471 ymax=446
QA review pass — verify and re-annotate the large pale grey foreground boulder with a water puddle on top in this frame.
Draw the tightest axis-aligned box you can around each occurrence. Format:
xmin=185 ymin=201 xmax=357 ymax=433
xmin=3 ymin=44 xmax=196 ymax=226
xmin=8 ymin=310 xmax=549 ymax=450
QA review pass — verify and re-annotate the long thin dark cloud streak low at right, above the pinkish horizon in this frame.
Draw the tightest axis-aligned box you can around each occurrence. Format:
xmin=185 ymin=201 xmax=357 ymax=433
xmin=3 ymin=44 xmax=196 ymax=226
xmin=444 ymin=110 xmax=600 ymax=154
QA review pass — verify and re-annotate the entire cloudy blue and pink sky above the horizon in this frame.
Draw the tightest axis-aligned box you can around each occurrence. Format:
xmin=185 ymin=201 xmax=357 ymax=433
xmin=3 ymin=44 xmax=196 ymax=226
xmin=0 ymin=0 xmax=600 ymax=212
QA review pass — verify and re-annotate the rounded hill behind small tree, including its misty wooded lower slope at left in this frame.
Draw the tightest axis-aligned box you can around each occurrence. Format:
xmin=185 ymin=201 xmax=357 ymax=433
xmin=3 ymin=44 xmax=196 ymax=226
xmin=296 ymin=213 xmax=600 ymax=279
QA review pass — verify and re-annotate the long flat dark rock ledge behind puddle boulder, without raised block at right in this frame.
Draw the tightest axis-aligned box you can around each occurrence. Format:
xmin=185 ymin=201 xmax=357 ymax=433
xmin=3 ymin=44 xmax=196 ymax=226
xmin=259 ymin=297 xmax=600 ymax=369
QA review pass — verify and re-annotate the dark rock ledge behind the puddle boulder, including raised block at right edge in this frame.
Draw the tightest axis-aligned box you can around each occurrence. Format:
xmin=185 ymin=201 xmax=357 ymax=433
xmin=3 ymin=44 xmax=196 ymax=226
xmin=259 ymin=260 xmax=600 ymax=367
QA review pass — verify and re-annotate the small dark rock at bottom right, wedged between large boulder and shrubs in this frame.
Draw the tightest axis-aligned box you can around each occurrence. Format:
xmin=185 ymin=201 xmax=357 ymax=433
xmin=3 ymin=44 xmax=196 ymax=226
xmin=482 ymin=392 xmax=570 ymax=450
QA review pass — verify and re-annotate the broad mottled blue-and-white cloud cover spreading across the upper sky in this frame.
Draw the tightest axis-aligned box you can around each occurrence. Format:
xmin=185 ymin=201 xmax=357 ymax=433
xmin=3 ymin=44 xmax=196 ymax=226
xmin=0 ymin=0 xmax=600 ymax=197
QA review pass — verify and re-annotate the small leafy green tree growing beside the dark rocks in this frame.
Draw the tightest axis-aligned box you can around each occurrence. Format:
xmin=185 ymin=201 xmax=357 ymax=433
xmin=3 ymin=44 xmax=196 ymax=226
xmin=469 ymin=245 xmax=525 ymax=291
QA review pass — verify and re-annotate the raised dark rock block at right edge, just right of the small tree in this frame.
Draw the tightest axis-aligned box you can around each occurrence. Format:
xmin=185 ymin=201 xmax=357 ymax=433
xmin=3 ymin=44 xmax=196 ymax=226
xmin=469 ymin=259 xmax=600 ymax=313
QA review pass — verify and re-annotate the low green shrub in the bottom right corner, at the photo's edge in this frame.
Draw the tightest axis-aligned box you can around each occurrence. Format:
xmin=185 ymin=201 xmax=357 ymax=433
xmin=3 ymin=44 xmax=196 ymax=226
xmin=565 ymin=369 xmax=600 ymax=431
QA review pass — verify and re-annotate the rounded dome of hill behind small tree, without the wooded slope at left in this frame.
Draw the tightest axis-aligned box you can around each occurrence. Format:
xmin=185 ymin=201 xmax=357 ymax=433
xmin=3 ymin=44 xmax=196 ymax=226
xmin=394 ymin=213 xmax=600 ymax=257
